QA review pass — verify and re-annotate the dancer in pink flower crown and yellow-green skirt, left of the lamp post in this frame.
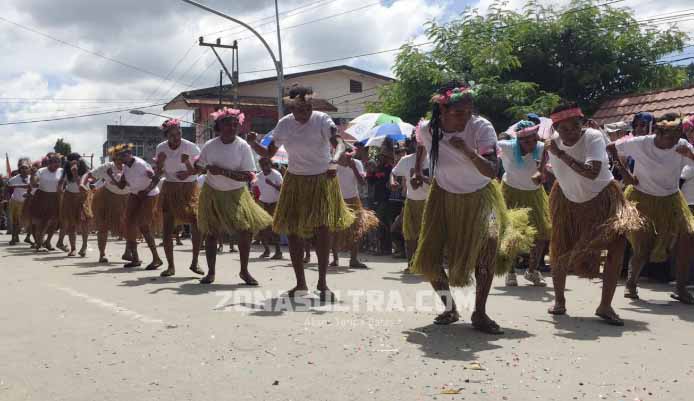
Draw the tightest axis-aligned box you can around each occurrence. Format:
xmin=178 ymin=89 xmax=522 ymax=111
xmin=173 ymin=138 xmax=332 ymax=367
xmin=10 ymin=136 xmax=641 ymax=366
xmin=196 ymin=108 xmax=272 ymax=286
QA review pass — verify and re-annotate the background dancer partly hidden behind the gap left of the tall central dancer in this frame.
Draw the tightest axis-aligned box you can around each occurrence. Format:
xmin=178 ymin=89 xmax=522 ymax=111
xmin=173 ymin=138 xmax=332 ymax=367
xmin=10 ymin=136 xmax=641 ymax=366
xmin=256 ymin=157 xmax=284 ymax=260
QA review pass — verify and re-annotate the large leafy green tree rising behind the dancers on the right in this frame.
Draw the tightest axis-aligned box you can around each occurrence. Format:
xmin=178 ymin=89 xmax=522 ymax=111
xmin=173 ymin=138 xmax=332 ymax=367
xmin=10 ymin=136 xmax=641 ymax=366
xmin=370 ymin=0 xmax=687 ymax=129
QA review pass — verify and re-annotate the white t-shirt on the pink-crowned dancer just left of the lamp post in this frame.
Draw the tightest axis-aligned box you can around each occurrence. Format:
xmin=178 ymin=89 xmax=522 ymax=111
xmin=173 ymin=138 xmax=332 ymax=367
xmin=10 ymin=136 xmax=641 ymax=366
xmin=198 ymin=137 xmax=255 ymax=191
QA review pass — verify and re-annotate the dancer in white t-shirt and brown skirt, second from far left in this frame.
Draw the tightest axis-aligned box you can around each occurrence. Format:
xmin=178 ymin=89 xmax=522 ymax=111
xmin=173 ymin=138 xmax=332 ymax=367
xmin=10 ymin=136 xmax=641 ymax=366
xmin=31 ymin=152 xmax=63 ymax=252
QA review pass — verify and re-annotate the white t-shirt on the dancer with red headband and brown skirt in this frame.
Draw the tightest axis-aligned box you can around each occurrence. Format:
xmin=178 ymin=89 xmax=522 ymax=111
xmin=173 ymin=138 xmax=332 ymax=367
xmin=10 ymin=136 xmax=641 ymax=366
xmin=549 ymin=128 xmax=614 ymax=203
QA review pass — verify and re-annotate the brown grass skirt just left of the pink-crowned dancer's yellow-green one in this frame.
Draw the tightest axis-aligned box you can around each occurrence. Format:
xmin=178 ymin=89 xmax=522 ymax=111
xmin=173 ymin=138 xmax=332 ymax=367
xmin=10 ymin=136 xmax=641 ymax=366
xmin=159 ymin=181 xmax=200 ymax=225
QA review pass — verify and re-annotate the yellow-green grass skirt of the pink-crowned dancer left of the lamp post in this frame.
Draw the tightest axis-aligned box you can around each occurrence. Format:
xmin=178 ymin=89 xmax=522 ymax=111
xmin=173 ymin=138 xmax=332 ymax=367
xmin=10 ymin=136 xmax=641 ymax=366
xmin=198 ymin=184 xmax=272 ymax=237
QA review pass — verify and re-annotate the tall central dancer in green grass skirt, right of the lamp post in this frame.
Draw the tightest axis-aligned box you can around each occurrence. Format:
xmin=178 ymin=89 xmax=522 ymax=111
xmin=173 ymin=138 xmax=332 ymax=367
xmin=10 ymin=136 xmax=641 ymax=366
xmin=248 ymin=87 xmax=354 ymax=300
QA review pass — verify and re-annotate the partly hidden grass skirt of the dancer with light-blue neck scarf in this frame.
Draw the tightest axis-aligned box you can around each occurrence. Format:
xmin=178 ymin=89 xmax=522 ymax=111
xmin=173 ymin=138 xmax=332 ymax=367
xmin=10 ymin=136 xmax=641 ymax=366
xmin=501 ymin=181 xmax=552 ymax=241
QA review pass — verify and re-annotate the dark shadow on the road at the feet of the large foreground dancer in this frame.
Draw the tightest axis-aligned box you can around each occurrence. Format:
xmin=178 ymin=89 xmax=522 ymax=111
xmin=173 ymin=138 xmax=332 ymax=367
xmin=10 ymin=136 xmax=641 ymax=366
xmin=403 ymin=323 xmax=532 ymax=361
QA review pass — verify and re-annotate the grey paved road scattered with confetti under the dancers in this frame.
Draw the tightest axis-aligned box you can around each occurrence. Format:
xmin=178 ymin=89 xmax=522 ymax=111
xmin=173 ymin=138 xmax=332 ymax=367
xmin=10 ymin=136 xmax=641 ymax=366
xmin=0 ymin=236 xmax=694 ymax=401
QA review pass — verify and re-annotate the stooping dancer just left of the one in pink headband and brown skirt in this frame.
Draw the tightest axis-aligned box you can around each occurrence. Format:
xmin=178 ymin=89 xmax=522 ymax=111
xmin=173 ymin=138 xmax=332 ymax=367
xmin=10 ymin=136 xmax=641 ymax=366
xmin=118 ymin=145 xmax=164 ymax=270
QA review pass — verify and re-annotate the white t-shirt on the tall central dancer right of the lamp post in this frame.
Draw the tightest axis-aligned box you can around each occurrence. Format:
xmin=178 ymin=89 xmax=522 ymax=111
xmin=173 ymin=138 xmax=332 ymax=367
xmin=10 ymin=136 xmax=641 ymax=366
xmin=272 ymin=111 xmax=335 ymax=175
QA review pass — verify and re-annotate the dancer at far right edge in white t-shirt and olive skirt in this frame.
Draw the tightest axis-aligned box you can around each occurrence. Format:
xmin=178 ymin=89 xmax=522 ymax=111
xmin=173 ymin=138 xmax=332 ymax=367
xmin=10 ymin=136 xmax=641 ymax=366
xmin=607 ymin=115 xmax=694 ymax=305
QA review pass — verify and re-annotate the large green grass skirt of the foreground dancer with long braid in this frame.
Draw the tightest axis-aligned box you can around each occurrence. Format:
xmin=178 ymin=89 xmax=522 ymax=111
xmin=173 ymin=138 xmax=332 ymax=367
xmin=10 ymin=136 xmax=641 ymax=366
xmin=412 ymin=181 xmax=535 ymax=286
